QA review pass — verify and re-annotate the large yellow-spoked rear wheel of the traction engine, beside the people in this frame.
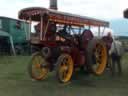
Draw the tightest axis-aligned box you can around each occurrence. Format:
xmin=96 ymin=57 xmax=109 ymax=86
xmin=87 ymin=38 xmax=107 ymax=75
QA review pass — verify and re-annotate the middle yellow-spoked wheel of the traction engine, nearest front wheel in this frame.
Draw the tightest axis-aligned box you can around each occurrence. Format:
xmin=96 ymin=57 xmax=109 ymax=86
xmin=56 ymin=54 xmax=73 ymax=83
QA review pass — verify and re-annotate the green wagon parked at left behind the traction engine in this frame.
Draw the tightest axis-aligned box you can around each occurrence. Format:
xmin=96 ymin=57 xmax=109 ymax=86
xmin=0 ymin=16 xmax=30 ymax=54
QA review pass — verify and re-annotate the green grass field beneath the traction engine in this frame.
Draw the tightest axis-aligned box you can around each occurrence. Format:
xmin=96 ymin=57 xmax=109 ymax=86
xmin=0 ymin=54 xmax=128 ymax=96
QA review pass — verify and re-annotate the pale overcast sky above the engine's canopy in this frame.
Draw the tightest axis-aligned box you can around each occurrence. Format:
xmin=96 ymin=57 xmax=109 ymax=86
xmin=0 ymin=0 xmax=128 ymax=20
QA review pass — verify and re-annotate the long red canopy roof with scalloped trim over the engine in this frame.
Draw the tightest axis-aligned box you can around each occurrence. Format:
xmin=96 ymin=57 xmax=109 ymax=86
xmin=19 ymin=7 xmax=109 ymax=27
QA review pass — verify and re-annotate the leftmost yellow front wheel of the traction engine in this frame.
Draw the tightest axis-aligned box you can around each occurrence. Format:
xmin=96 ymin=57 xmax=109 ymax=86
xmin=28 ymin=52 xmax=49 ymax=80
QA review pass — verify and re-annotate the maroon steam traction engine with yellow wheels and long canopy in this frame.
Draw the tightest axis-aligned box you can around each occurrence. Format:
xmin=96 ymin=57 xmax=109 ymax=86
xmin=19 ymin=7 xmax=109 ymax=83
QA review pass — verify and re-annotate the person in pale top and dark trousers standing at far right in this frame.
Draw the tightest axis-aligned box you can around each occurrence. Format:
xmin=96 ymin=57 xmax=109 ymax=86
xmin=109 ymin=38 xmax=123 ymax=75
